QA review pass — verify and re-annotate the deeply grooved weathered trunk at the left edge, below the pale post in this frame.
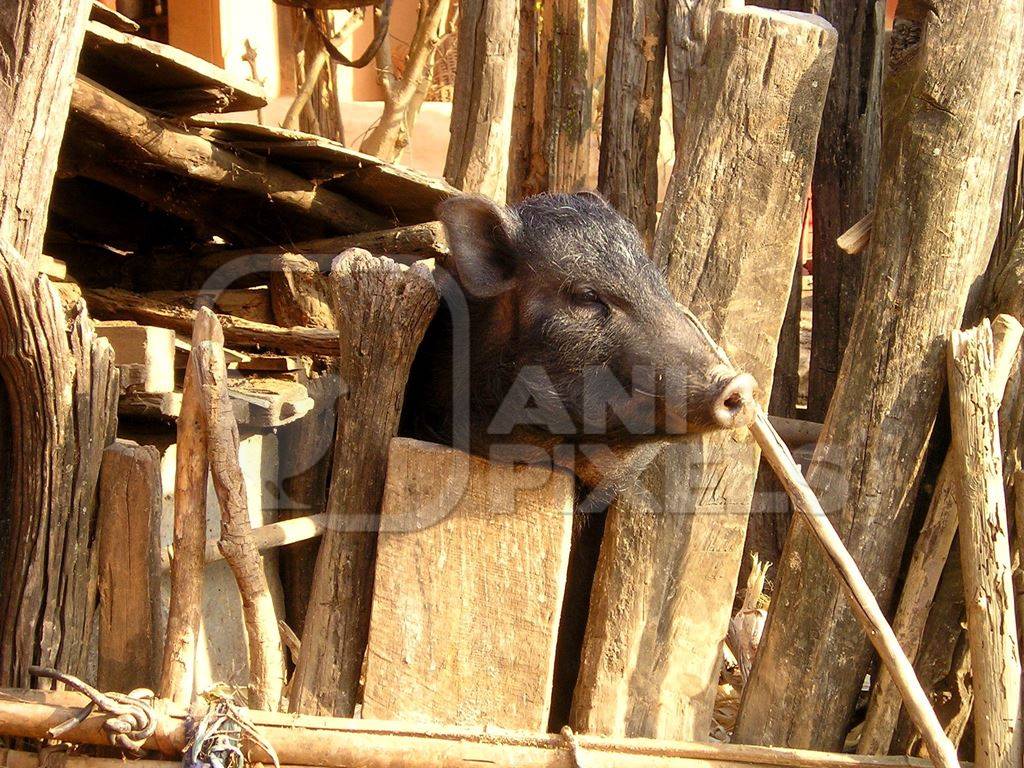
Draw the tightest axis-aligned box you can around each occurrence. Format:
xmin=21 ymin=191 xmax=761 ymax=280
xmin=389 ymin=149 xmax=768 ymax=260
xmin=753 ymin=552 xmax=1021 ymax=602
xmin=0 ymin=239 xmax=118 ymax=686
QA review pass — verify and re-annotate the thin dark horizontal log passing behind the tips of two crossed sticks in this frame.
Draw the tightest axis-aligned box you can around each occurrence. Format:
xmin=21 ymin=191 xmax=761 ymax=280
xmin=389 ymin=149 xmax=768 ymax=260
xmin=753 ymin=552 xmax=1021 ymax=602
xmin=82 ymin=288 xmax=338 ymax=356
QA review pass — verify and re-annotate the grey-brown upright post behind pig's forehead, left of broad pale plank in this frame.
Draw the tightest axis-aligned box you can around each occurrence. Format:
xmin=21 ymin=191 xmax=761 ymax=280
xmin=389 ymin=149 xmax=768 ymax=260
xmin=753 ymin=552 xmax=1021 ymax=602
xmin=597 ymin=0 xmax=666 ymax=247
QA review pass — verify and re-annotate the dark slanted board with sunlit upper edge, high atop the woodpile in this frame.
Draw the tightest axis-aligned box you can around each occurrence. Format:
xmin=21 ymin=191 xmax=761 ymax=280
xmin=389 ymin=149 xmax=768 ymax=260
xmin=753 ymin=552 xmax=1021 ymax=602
xmin=79 ymin=20 xmax=266 ymax=115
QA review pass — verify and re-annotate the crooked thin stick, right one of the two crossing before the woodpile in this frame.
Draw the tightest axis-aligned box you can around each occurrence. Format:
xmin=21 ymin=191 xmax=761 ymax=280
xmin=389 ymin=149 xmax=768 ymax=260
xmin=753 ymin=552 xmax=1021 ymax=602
xmin=191 ymin=339 xmax=285 ymax=711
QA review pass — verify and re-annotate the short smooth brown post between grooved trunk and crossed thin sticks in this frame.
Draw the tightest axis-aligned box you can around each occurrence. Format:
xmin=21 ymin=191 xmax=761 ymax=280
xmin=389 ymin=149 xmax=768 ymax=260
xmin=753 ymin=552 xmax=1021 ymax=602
xmin=96 ymin=440 xmax=163 ymax=691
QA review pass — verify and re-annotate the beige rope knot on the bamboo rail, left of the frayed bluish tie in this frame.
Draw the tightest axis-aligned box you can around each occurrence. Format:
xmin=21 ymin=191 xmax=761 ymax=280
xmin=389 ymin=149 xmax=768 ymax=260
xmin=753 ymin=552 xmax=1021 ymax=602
xmin=29 ymin=667 xmax=157 ymax=754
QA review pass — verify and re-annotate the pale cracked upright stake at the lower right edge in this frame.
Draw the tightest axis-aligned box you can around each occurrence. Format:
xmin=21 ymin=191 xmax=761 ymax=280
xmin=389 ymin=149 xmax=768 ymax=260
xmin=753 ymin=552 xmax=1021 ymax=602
xmin=947 ymin=321 xmax=1024 ymax=768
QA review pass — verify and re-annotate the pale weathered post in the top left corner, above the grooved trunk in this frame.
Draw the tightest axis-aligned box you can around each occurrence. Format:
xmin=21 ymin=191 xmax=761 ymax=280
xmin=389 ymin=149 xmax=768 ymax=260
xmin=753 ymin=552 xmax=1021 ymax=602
xmin=0 ymin=0 xmax=92 ymax=266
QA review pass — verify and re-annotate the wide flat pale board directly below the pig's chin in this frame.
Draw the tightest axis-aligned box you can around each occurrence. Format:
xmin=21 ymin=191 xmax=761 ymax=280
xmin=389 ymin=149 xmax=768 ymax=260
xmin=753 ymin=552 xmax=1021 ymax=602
xmin=362 ymin=438 xmax=573 ymax=730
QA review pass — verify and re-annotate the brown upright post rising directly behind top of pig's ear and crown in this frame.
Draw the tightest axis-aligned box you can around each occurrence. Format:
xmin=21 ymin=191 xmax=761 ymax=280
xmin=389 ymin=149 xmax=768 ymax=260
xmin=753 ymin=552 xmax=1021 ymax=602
xmin=509 ymin=0 xmax=594 ymax=200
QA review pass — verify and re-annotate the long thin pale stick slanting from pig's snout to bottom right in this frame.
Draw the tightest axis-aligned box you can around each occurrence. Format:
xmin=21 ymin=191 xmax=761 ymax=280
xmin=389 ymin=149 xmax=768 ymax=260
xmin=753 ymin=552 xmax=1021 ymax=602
xmin=689 ymin=314 xmax=959 ymax=768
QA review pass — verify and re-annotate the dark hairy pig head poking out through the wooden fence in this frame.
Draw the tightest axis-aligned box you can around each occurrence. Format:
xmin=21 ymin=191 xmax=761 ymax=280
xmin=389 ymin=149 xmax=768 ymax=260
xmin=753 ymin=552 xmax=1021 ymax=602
xmin=403 ymin=193 xmax=756 ymax=487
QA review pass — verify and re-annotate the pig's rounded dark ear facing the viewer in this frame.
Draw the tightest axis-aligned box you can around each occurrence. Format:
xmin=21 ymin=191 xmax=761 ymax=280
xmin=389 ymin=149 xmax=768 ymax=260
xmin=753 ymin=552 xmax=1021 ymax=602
xmin=437 ymin=195 xmax=521 ymax=298
